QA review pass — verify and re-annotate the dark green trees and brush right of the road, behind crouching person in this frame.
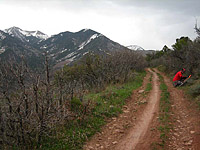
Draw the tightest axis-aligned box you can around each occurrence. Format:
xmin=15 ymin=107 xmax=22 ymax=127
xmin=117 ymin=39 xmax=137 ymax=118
xmin=146 ymin=25 xmax=200 ymax=106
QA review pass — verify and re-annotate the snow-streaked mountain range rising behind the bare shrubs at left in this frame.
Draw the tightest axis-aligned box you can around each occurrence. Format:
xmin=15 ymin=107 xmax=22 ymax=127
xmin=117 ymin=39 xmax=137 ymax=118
xmin=0 ymin=27 xmax=128 ymax=67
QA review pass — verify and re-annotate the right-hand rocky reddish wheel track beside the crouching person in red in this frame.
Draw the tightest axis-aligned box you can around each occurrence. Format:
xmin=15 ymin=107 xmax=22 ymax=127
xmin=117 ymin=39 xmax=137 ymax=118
xmin=157 ymin=69 xmax=200 ymax=150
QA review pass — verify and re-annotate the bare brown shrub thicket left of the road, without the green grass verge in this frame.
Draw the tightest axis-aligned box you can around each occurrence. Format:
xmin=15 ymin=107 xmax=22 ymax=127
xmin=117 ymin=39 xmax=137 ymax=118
xmin=0 ymin=51 xmax=146 ymax=149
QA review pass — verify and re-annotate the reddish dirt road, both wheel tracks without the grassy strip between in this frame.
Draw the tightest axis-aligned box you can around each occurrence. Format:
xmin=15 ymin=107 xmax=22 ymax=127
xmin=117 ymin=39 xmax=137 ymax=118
xmin=84 ymin=69 xmax=200 ymax=150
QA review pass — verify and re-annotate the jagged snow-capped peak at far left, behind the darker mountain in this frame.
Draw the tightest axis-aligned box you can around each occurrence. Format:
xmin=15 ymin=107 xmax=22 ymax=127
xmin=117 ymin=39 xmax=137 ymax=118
xmin=4 ymin=27 xmax=48 ymax=44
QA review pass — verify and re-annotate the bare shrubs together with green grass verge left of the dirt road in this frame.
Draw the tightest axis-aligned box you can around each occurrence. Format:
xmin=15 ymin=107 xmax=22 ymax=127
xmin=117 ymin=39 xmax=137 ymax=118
xmin=0 ymin=51 xmax=146 ymax=149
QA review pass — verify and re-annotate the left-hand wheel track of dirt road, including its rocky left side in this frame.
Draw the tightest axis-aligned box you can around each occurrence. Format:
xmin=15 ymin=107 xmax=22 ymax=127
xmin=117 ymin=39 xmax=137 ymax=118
xmin=84 ymin=69 xmax=160 ymax=150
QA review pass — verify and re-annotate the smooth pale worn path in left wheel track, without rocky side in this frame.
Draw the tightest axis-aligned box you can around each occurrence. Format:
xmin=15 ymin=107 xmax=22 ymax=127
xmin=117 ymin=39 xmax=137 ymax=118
xmin=115 ymin=70 xmax=160 ymax=150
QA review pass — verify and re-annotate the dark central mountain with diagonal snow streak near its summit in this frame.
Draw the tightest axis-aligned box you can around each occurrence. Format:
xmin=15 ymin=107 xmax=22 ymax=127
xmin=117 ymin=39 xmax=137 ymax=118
xmin=39 ymin=29 xmax=127 ymax=67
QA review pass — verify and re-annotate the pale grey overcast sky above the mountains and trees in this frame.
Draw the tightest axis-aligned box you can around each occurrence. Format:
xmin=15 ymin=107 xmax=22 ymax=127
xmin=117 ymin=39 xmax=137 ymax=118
xmin=0 ymin=0 xmax=200 ymax=49
